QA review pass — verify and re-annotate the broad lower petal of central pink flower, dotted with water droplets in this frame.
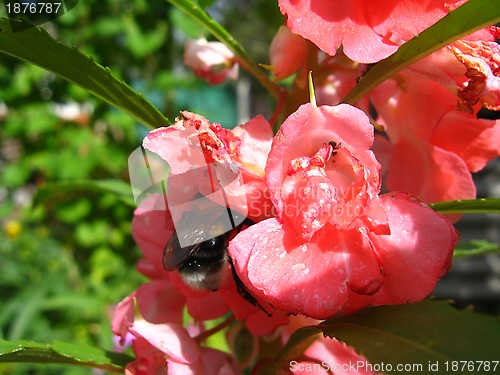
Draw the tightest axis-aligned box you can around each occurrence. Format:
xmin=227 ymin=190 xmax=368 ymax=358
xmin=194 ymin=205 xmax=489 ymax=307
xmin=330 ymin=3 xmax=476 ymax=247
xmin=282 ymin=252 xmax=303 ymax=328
xmin=229 ymin=219 xmax=382 ymax=319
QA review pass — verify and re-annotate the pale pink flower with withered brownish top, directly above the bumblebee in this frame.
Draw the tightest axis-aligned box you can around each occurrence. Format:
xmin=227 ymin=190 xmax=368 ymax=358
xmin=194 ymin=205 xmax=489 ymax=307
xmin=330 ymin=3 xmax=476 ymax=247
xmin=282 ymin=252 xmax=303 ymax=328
xmin=143 ymin=111 xmax=272 ymax=221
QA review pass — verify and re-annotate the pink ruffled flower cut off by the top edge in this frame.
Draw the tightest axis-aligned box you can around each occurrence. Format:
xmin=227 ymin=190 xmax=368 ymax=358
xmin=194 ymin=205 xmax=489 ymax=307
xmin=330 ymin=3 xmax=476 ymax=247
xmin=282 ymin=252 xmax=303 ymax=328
xmin=279 ymin=0 xmax=465 ymax=63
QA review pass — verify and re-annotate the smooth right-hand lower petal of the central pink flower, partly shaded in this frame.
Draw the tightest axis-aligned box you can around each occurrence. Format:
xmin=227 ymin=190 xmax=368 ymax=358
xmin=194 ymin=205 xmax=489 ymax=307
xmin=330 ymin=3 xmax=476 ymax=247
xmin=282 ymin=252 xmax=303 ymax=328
xmin=369 ymin=193 xmax=458 ymax=305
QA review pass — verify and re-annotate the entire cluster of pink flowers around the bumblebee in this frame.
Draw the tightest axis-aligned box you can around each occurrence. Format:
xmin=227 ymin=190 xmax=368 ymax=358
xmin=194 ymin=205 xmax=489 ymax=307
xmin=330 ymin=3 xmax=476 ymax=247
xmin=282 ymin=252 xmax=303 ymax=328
xmin=113 ymin=0 xmax=500 ymax=374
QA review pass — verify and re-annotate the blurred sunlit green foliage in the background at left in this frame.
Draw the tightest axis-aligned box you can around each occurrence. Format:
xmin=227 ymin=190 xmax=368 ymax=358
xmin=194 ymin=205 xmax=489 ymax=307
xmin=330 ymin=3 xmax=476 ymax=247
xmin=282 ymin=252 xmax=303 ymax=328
xmin=0 ymin=0 xmax=282 ymax=375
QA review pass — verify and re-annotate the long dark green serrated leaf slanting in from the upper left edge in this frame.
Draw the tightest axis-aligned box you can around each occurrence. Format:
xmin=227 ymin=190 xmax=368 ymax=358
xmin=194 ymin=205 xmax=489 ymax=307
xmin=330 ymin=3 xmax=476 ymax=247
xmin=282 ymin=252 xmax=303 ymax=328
xmin=0 ymin=18 xmax=169 ymax=128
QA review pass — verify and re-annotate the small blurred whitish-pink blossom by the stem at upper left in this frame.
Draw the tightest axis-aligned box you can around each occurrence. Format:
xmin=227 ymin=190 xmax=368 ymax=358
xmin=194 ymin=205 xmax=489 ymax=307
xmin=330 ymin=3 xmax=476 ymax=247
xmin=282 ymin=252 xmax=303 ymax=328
xmin=184 ymin=38 xmax=238 ymax=85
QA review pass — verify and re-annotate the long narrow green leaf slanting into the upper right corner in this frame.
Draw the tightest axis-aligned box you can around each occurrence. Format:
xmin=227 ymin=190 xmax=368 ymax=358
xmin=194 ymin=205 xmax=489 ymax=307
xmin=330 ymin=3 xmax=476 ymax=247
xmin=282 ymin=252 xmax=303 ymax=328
xmin=343 ymin=0 xmax=500 ymax=104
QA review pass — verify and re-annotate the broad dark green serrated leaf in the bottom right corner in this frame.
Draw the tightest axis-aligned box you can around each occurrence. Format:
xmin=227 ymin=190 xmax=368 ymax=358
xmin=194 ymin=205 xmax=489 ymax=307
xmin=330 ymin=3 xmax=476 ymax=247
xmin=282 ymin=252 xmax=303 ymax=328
xmin=285 ymin=301 xmax=500 ymax=374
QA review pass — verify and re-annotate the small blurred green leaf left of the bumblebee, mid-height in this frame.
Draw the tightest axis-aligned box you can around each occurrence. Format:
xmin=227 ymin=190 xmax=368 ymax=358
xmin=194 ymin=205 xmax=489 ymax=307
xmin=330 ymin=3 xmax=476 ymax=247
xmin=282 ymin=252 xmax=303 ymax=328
xmin=33 ymin=180 xmax=136 ymax=207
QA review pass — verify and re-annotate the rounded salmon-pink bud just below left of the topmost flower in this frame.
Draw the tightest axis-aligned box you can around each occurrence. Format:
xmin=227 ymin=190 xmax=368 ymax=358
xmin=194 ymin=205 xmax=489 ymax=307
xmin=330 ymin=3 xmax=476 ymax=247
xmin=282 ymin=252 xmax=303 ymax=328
xmin=269 ymin=26 xmax=307 ymax=81
